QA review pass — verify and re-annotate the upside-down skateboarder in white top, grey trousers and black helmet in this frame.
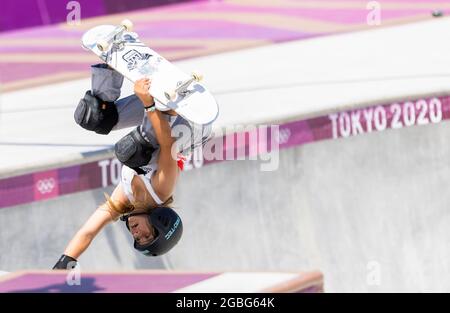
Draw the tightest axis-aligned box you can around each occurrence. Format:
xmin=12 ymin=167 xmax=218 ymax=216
xmin=53 ymin=64 xmax=211 ymax=269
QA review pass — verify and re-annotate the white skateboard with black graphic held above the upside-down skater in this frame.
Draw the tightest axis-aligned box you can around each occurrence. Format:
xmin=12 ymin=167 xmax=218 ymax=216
xmin=81 ymin=20 xmax=219 ymax=125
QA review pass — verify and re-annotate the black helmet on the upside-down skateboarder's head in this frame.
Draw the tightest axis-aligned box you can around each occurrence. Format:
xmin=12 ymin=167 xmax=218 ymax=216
xmin=121 ymin=207 xmax=183 ymax=256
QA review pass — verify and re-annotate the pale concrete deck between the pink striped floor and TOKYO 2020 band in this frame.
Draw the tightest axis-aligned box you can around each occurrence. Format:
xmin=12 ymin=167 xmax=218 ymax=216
xmin=0 ymin=17 xmax=450 ymax=177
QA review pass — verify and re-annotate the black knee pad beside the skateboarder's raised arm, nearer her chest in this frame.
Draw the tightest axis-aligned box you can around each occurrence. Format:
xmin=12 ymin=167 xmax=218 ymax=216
xmin=114 ymin=127 xmax=155 ymax=168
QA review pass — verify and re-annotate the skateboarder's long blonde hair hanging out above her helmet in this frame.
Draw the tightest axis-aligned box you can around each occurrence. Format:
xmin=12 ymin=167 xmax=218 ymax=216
xmin=104 ymin=179 xmax=173 ymax=215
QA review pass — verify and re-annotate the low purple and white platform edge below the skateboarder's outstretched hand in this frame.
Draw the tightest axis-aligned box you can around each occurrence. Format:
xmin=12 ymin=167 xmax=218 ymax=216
xmin=0 ymin=270 xmax=323 ymax=293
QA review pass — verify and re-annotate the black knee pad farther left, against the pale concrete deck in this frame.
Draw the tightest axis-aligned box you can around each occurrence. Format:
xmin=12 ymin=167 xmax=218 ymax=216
xmin=74 ymin=90 xmax=119 ymax=135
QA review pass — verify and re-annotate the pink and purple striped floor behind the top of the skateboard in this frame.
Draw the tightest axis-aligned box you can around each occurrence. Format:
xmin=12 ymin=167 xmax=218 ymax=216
xmin=0 ymin=0 xmax=450 ymax=92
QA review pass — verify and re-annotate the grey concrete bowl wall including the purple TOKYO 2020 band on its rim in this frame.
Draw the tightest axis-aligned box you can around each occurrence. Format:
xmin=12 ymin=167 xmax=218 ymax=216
xmin=0 ymin=96 xmax=450 ymax=292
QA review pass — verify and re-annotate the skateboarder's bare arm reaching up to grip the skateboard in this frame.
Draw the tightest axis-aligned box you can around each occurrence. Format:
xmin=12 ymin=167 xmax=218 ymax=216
xmin=134 ymin=79 xmax=179 ymax=201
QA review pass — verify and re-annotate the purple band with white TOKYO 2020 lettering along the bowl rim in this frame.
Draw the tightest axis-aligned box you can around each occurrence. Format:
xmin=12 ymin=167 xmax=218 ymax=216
xmin=0 ymin=96 xmax=450 ymax=209
